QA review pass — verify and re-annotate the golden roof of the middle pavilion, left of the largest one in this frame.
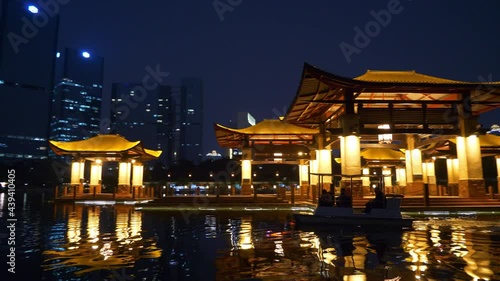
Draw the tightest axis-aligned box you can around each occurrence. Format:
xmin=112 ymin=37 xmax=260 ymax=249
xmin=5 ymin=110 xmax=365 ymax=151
xmin=214 ymin=119 xmax=319 ymax=147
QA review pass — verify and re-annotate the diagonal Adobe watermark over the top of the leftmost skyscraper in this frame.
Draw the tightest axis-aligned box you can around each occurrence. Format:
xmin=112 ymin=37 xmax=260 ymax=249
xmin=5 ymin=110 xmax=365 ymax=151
xmin=7 ymin=0 xmax=70 ymax=54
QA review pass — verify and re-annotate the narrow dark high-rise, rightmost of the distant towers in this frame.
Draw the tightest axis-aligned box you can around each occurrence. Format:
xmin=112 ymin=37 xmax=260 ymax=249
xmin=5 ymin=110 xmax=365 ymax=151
xmin=178 ymin=78 xmax=204 ymax=164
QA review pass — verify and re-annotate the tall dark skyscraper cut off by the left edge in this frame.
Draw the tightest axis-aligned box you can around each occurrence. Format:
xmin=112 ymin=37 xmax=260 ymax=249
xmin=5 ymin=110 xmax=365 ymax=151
xmin=0 ymin=0 xmax=59 ymax=160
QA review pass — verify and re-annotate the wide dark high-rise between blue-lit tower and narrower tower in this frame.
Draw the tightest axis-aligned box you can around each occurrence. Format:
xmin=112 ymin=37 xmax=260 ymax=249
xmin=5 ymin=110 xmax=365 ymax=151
xmin=110 ymin=83 xmax=175 ymax=166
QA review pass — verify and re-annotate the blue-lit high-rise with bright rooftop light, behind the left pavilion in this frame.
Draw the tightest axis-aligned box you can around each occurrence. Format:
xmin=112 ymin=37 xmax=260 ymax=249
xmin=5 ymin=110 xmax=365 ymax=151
xmin=50 ymin=48 xmax=106 ymax=141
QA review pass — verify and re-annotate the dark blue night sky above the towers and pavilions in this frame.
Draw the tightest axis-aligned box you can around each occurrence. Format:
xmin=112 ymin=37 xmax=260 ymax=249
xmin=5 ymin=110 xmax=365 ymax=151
xmin=59 ymin=0 xmax=500 ymax=152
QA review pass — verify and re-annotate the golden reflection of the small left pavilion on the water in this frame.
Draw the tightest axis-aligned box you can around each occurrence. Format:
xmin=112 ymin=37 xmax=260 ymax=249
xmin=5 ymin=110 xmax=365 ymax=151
xmin=42 ymin=202 xmax=161 ymax=278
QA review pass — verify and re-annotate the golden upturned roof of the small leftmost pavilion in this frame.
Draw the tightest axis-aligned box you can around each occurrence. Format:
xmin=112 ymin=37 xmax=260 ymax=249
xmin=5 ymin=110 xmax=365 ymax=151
xmin=49 ymin=135 xmax=162 ymax=160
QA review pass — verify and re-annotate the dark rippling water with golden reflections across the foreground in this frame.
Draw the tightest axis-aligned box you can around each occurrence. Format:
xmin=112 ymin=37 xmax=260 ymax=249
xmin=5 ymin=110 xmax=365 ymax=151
xmin=0 ymin=191 xmax=500 ymax=281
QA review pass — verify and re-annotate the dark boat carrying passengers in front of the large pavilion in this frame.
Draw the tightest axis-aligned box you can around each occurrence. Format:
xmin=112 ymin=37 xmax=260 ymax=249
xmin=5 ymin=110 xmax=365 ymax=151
xmin=293 ymin=196 xmax=413 ymax=227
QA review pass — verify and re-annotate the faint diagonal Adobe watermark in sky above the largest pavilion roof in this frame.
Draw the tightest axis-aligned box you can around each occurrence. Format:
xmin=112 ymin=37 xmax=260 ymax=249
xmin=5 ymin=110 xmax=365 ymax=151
xmin=339 ymin=0 xmax=411 ymax=63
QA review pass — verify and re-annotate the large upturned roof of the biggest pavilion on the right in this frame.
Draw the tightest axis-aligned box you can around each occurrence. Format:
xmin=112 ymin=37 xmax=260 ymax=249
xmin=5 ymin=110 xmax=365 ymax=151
xmin=284 ymin=63 xmax=500 ymax=127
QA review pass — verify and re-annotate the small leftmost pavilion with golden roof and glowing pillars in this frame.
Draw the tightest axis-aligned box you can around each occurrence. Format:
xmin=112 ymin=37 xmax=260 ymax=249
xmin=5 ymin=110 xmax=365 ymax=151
xmin=49 ymin=134 xmax=162 ymax=195
